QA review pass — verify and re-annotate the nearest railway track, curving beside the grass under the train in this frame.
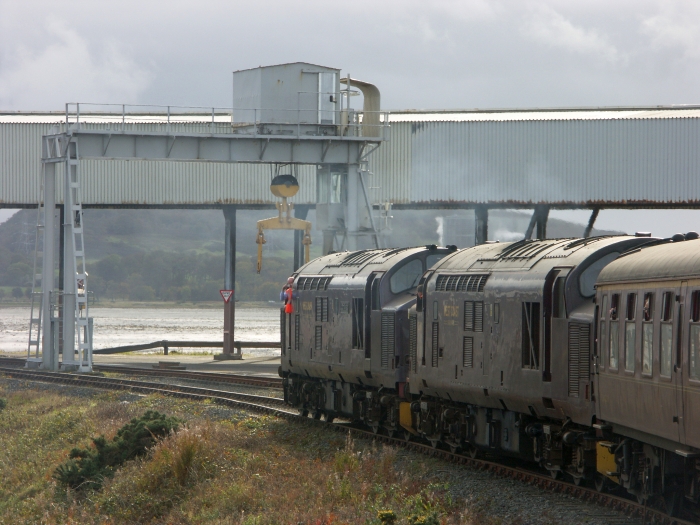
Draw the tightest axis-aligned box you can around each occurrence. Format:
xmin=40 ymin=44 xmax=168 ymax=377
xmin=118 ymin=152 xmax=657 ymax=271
xmin=0 ymin=359 xmax=697 ymax=525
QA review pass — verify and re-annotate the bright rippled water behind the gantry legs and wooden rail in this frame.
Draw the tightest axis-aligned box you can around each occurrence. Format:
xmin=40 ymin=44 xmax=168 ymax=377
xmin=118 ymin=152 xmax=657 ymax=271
xmin=0 ymin=305 xmax=280 ymax=356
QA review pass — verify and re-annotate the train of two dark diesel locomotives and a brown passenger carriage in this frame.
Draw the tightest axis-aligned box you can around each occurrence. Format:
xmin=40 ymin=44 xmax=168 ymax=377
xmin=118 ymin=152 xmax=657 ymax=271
xmin=280 ymin=234 xmax=700 ymax=511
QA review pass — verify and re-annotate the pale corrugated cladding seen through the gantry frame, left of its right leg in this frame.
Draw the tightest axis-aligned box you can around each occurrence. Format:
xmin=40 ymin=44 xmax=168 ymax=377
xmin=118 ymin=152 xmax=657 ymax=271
xmin=0 ymin=124 xmax=316 ymax=205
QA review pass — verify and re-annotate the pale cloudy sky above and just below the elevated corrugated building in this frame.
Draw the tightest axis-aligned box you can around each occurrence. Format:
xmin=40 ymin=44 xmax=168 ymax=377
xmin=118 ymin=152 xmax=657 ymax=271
xmin=0 ymin=0 xmax=700 ymax=234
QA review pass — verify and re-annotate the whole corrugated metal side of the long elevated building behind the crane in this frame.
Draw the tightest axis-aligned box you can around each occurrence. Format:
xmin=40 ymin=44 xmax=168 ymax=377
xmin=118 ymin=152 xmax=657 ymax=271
xmin=0 ymin=109 xmax=700 ymax=205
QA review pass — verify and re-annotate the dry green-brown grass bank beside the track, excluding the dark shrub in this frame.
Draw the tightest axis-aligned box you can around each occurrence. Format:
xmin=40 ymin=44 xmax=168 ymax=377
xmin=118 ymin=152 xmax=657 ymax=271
xmin=0 ymin=382 xmax=482 ymax=525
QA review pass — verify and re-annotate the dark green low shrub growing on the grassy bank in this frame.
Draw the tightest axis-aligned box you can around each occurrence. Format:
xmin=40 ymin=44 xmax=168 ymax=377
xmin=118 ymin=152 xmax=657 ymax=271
xmin=54 ymin=410 xmax=179 ymax=489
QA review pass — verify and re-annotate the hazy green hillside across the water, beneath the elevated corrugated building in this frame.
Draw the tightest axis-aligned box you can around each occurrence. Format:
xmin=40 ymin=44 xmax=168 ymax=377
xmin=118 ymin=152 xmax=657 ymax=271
xmin=0 ymin=209 xmax=624 ymax=302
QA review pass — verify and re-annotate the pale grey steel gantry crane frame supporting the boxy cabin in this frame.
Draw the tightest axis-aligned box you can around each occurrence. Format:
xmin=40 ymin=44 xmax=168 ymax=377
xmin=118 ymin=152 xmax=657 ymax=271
xmin=40 ymin=116 xmax=388 ymax=372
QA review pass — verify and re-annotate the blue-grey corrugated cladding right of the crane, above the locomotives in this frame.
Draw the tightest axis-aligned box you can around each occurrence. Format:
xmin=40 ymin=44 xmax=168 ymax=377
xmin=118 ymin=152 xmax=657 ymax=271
xmin=402 ymin=118 xmax=700 ymax=204
